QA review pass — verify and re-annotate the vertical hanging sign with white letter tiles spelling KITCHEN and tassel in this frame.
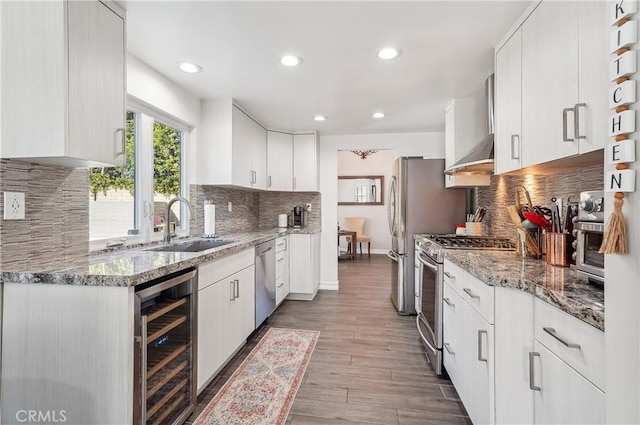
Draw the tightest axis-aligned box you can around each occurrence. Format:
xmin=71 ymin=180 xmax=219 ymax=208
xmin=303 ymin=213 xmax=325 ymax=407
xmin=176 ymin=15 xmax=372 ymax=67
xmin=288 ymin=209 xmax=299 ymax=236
xmin=600 ymin=0 xmax=638 ymax=254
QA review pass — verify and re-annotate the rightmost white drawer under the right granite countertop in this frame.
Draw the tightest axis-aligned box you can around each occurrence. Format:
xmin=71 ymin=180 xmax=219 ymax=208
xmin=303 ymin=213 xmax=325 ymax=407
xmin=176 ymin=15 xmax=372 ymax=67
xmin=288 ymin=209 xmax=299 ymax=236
xmin=534 ymin=299 xmax=605 ymax=390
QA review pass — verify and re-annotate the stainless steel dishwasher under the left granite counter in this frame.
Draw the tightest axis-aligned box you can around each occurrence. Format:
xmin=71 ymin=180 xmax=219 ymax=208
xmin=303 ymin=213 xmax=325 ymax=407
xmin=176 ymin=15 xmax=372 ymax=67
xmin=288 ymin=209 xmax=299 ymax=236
xmin=256 ymin=239 xmax=276 ymax=328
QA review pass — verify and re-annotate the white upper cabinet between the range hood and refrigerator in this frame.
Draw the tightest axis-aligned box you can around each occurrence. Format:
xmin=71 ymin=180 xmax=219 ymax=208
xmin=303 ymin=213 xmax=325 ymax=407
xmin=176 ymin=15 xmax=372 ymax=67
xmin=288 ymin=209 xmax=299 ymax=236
xmin=444 ymin=97 xmax=491 ymax=187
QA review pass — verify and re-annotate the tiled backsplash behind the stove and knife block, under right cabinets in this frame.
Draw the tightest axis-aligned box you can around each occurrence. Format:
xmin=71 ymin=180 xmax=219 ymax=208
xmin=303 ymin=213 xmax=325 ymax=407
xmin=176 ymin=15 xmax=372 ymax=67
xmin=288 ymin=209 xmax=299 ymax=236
xmin=474 ymin=165 xmax=604 ymax=239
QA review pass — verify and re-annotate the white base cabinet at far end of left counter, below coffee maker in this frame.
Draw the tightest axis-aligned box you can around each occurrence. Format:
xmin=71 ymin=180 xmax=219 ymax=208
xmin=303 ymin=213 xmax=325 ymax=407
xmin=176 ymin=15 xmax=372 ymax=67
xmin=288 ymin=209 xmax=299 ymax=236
xmin=288 ymin=233 xmax=320 ymax=300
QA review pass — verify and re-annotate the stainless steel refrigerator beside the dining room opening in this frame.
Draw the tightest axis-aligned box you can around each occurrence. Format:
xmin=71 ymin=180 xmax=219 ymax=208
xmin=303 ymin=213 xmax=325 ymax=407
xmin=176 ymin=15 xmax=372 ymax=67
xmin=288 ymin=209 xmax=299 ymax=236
xmin=387 ymin=157 xmax=467 ymax=314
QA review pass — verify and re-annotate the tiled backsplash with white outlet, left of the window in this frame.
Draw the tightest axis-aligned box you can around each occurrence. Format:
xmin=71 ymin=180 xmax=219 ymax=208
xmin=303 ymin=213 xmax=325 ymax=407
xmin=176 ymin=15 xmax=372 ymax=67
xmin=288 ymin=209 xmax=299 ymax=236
xmin=0 ymin=159 xmax=89 ymax=270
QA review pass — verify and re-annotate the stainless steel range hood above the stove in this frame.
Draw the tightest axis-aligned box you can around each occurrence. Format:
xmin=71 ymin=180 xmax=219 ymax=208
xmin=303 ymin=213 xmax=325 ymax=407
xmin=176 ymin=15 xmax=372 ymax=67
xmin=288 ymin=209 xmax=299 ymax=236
xmin=445 ymin=74 xmax=494 ymax=174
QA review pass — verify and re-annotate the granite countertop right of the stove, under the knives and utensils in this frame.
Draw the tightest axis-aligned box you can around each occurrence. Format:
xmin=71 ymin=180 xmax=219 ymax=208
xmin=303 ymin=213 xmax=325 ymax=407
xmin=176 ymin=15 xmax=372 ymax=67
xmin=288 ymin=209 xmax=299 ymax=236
xmin=415 ymin=235 xmax=604 ymax=331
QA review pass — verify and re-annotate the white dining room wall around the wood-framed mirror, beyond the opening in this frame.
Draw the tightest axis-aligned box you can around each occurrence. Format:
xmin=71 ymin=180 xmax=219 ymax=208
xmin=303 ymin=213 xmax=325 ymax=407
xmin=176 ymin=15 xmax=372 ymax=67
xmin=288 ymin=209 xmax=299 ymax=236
xmin=337 ymin=149 xmax=396 ymax=254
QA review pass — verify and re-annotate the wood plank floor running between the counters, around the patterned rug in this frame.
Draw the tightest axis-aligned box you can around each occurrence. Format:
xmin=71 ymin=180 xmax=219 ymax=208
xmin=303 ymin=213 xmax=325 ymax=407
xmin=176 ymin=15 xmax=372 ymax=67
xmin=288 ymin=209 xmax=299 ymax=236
xmin=187 ymin=255 xmax=471 ymax=425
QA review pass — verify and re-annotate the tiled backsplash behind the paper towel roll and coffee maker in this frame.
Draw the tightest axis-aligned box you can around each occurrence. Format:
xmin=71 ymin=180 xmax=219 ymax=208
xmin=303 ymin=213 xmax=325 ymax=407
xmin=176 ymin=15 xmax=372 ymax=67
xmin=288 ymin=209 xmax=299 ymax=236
xmin=189 ymin=185 xmax=321 ymax=235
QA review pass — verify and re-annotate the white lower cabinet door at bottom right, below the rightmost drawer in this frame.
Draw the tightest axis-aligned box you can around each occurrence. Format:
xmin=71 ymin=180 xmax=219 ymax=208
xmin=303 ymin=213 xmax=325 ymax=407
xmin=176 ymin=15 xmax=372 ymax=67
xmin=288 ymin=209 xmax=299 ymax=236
xmin=532 ymin=341 xmax=606 ymax=424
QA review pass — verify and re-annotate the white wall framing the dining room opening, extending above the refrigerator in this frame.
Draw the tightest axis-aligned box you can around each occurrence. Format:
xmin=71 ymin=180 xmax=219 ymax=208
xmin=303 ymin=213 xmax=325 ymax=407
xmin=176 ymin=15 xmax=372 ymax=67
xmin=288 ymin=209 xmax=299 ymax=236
xmin=318 ymin=132 xmax=444 ymax=290
